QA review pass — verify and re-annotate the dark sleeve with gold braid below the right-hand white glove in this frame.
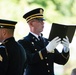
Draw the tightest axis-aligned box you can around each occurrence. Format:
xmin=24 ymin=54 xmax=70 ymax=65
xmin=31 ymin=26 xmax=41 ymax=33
xmin=54 ymin=49 xmax=70 ymax=65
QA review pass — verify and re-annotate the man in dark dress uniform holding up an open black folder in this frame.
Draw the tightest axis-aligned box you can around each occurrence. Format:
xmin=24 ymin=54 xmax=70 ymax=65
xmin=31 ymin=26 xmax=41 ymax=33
xmin=18 ymin=8 xmax=69 ymax=75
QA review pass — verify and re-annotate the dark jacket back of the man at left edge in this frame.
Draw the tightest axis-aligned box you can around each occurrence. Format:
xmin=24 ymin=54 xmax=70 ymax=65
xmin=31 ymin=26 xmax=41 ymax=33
xmin=0 ymin=37 xmax=26 ymax=75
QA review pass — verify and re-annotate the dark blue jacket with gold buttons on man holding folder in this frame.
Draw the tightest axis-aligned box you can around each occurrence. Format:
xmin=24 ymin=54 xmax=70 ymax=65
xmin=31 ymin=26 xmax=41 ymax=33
xmin=19 ymin=33 xmax=69 ymax=75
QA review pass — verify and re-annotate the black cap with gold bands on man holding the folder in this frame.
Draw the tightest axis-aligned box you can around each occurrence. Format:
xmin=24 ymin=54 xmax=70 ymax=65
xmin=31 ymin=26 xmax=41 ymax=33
xmin=23 ymin=8 xmax=44 ymax=22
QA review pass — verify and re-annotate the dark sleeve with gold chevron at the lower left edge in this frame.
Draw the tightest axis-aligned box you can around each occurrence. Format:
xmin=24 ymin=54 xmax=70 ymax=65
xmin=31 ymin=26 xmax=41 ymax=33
xmin=0 ymin=45 xmax=8 ymax=75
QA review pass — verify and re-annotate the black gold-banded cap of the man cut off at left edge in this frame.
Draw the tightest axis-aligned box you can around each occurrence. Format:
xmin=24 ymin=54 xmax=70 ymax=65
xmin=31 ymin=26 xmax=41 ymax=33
xmin=0 ymin=19 xmax=17 ymax=29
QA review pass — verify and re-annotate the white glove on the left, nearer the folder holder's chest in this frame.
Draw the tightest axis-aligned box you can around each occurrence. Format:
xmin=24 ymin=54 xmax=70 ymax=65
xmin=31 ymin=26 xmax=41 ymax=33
xmin=46 ymin=37 xmax=61 ymax=52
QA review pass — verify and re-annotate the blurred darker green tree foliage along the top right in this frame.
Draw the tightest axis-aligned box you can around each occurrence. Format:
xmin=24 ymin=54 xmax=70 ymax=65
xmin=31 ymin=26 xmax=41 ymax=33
xmin=27 ymin=0 xmax=74 ymax=16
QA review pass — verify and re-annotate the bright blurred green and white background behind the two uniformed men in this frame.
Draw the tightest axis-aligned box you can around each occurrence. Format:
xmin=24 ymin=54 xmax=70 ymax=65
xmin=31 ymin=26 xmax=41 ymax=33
xmin=0 ymin=0 xmax=76 ymax=75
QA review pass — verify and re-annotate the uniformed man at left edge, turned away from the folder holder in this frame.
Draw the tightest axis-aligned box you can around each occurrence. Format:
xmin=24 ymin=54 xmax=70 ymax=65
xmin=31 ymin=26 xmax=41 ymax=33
xmin=0 ymin=19 xmax=26 ymax=75
